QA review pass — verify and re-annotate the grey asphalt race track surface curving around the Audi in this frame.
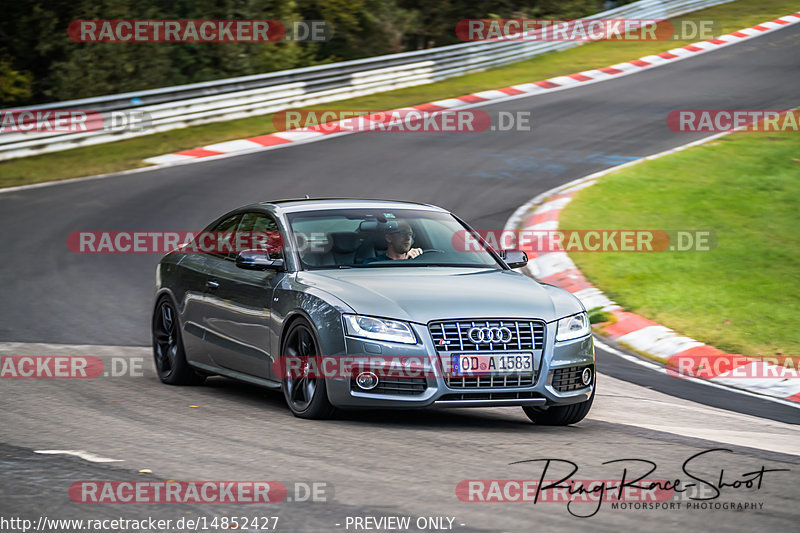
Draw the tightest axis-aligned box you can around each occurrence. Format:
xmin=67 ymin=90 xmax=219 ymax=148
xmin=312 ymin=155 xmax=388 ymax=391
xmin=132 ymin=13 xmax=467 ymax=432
xmin=0 ymin=18 xmax=800 ymax=531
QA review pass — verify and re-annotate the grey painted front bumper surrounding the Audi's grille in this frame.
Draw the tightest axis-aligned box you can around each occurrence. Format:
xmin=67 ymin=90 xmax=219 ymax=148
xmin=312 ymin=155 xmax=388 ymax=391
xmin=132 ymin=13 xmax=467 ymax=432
xmin=326 ymin=323 xmax=595 ymax=409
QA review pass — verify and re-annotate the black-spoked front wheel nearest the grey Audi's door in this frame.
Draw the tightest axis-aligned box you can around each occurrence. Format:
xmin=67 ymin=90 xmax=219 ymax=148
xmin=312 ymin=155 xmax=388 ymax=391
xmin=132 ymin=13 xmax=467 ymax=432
xmin=281 ymin=319 xmax=334 ymax=420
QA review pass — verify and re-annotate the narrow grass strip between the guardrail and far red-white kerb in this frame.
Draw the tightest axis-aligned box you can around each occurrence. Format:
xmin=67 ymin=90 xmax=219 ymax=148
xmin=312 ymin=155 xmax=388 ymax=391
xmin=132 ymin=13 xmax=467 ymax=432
xmin=0 ymin=0 xmax=798 ymax=187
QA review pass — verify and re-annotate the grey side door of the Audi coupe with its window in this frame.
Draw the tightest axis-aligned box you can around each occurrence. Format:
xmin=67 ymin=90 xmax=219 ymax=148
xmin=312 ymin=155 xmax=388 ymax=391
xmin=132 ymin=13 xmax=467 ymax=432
xmin=206 ymin=212 xmax=285 ymax=378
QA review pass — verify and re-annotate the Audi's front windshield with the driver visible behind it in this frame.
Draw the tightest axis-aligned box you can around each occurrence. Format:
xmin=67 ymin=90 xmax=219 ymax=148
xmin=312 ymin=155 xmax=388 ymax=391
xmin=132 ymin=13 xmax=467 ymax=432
xmin=287 ymin=209 xmax=502 ymax=269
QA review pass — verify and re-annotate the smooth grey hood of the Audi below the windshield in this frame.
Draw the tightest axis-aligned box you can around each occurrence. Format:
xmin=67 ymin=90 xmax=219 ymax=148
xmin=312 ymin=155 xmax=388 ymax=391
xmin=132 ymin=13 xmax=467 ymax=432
xmin=297 ymin=267 xmax=583 ymax=324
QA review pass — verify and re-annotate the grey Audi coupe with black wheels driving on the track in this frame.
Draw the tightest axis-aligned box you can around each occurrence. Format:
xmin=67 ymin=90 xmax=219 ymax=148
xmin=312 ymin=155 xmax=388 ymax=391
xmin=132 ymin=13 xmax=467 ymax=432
xmin=152 ymin=198 xmax=595 ymax=425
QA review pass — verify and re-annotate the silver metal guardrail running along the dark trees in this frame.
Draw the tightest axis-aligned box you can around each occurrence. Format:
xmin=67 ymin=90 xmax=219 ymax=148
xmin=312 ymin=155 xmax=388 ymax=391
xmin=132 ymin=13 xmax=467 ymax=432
xmin=0 ymin=0 xmax=733 ymax=161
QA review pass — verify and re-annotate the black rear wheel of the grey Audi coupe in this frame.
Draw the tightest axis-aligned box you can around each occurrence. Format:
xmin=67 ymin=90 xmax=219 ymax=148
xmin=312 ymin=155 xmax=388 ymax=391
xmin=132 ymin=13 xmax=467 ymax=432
xmin=152 ymin=296 xmax=206 ymax=385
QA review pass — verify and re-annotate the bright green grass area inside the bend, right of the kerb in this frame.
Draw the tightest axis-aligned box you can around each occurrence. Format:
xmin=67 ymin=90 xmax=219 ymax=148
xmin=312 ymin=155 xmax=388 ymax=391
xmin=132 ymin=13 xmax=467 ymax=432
xmin=560 ymin=132 xmax=800 ymax=359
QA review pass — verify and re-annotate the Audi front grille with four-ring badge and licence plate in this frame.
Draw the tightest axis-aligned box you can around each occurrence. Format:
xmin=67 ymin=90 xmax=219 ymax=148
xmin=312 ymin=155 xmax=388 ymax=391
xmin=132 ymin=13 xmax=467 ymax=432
xmin=428 ymin=319 xmax=545 ymax=389
